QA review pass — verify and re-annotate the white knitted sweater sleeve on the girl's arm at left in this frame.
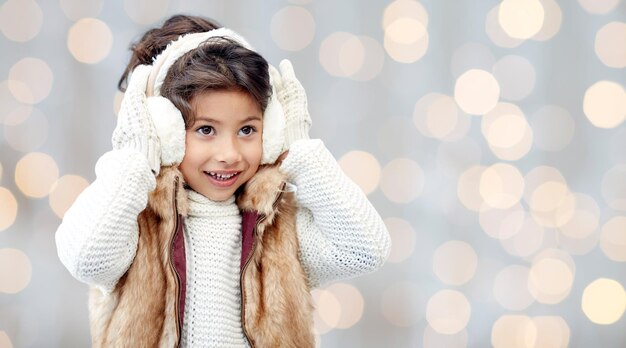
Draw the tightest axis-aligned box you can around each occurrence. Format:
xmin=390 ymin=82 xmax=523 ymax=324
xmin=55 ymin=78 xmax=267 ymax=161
xmin=55 ymin=150 xmax=156 ymax=292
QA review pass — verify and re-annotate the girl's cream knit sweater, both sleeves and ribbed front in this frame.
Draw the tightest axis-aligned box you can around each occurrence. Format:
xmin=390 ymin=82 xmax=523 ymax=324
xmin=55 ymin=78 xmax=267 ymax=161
xmin=56 ymin=139 xmax=390 ymax=347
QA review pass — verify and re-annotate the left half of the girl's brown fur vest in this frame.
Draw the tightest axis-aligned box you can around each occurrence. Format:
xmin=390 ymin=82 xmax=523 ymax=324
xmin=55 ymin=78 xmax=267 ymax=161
xmin=89 ymin=167 xmax=187 ymax=348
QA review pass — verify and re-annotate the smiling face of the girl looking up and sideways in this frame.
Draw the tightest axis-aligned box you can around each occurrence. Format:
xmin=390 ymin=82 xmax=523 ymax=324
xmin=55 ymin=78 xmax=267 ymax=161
xmin=179 ymin=90 xmax=263 ymax=201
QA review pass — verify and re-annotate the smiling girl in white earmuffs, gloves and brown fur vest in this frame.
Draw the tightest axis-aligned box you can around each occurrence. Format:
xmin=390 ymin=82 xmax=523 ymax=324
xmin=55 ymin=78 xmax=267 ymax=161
xmin=56 ymin=16 xmax=389 ymax=347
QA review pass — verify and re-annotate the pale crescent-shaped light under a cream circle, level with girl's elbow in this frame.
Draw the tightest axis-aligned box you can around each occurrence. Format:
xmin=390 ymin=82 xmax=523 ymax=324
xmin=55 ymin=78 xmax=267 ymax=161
xmin=478 ymin=204 xmax=526 ymax=239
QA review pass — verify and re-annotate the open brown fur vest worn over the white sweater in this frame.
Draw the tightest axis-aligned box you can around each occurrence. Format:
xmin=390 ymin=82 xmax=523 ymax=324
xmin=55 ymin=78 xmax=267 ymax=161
xmin=89 ymin=166 xmax=315 ymax=347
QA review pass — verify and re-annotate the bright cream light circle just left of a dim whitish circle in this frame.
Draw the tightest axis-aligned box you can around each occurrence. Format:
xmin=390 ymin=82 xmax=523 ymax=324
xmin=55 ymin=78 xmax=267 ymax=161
xmin=454 ymin=69 xmax=500 ymax=115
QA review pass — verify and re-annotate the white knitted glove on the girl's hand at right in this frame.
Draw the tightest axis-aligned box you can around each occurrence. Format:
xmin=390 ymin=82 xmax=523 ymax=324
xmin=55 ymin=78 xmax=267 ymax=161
xmin=270 ymin=59 xmax=311 ymax=149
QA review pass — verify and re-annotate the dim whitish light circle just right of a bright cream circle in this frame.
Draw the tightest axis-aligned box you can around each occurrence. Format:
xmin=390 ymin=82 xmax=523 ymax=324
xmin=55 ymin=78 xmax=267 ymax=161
xmin=493 ymin=55 xmax=536 ymax=100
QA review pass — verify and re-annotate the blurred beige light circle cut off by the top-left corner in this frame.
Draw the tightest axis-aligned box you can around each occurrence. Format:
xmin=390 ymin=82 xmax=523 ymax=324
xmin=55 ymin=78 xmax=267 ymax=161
xmin=0 ymin=0 xmax=43 ymax=42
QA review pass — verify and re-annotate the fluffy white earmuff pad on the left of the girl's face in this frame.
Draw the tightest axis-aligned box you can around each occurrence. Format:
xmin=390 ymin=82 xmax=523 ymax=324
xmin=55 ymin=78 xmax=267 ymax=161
xmin=147 ymin=96 xmax=186 ymax=166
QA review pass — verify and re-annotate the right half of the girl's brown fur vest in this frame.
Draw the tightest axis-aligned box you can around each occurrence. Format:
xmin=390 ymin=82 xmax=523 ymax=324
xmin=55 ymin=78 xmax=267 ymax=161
xmin=238 ymin=166 xmax=315 ymax=348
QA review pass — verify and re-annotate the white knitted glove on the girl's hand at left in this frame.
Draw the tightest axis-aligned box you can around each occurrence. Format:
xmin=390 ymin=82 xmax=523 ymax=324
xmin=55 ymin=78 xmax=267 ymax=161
xmin=111 ymin=65 xmax=161 ymax=175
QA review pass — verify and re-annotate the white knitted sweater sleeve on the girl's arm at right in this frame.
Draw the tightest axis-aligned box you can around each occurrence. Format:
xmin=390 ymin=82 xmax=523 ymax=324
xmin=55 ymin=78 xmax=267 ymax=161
xmin=281 ymin=139 xmax=390 ymax=287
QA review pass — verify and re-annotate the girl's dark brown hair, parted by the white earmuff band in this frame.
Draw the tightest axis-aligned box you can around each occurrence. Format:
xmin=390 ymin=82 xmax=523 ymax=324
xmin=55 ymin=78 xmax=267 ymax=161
xmin=118 ymin=15 xmax=272 ymax=127
